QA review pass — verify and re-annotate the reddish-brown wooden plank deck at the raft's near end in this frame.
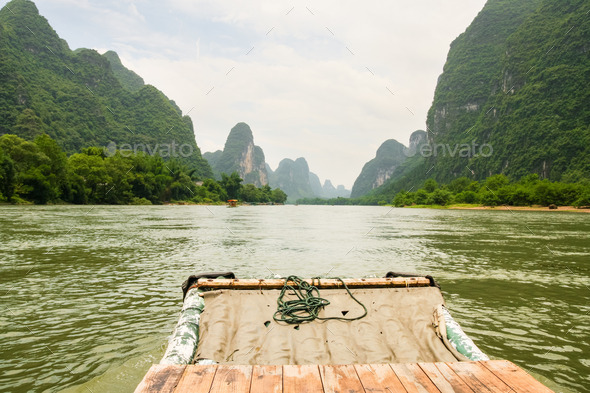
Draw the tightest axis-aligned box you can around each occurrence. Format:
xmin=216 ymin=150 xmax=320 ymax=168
xmin=135 ymin=360 xmax=552 ymax=393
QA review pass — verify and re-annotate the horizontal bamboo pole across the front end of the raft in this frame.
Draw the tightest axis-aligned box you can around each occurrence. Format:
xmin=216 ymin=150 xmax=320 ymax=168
xmin=197 ymin=277 xmax=430 ymax=289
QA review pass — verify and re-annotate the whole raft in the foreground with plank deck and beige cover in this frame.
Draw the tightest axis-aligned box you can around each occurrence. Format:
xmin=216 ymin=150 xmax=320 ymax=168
xmin=135 ymin=272 xmax=551 ymax=393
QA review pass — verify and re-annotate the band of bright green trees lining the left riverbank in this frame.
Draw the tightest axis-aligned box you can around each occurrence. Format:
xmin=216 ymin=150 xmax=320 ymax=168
xmin=0 ymin=134 xmax=287 ymax=205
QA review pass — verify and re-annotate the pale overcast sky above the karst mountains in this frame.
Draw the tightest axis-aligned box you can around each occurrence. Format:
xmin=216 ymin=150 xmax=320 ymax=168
xmin=6 ymin=0 xmax=485 ymax=189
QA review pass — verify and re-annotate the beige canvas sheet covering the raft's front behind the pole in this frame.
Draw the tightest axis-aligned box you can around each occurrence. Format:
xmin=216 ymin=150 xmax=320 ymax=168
xmin=195 ymin=287 xmax=464 ymax=365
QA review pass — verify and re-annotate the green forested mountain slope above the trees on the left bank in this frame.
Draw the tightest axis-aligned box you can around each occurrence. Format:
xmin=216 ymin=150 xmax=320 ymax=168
xmin=0 ymin=0 xmax=213 ymax=178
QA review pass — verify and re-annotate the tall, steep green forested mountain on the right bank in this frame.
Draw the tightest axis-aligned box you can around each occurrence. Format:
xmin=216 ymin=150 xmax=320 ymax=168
xmin=366 ymin=0 xmax=590 ymax=195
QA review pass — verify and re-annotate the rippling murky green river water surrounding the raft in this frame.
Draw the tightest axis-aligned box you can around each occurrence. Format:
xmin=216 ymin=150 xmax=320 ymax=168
xmin=0 ymin=206 xmax=590 ymax=393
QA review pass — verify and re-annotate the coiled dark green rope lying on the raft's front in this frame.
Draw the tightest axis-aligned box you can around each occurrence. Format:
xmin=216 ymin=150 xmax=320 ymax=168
xmin=273 ymin=276 xmax=367 ymax=324
